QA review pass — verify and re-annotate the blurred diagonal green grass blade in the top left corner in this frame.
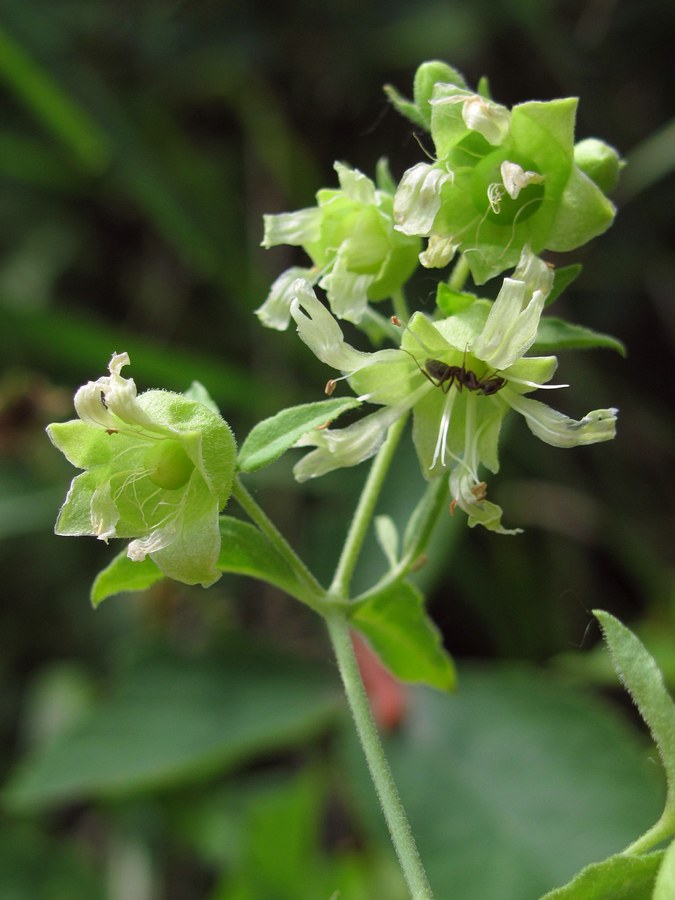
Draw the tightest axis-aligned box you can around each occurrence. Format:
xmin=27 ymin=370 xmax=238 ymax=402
xmin=0 ymin=25 xmax=110 ymax=172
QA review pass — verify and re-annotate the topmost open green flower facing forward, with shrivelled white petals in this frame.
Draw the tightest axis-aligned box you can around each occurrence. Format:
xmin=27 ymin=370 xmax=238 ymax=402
xmin=394 ymin=64 xmax=618 ymax=284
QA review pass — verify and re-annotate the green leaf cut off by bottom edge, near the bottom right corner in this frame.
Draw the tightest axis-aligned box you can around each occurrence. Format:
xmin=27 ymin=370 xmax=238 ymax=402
xmin=541 ymin=852 xmax=673 ymax=900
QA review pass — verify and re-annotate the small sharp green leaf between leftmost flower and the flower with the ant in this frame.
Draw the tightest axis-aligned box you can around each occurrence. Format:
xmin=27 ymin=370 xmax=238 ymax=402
xmin=239 ymin=397 xmax=361 ymax=472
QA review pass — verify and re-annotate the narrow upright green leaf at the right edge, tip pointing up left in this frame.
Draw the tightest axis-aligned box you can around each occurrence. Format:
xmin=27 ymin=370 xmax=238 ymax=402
xmin=593 ymin=609 xmax=675 ymax=833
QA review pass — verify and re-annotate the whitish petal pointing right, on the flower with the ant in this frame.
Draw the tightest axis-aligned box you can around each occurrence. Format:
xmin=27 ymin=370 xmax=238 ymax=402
xmin=504 ymin=391 xmax=618 ymax=447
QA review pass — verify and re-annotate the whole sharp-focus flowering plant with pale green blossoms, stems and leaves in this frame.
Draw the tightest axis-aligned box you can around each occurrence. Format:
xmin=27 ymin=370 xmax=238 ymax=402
xmin=48 ymin=62 xmax=675 ymax=900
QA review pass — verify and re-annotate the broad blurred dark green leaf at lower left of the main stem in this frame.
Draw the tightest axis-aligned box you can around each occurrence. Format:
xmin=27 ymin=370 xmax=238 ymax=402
xmin=3 ymin=638 xmax=339 ymax=812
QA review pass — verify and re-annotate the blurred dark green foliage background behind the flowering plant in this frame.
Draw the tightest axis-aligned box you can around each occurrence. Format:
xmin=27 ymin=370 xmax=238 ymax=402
xmin=0 ymin=0 xmax=675 ymax=900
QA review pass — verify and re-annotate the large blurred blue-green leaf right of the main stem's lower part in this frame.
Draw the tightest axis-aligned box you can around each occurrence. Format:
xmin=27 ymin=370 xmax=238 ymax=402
xmin=348 ymin=667 xmax=661 ymax=900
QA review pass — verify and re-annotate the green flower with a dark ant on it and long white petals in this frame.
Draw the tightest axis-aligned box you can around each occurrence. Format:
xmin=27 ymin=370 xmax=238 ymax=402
xmin=291 ymin=250 xmax=617 ymax=534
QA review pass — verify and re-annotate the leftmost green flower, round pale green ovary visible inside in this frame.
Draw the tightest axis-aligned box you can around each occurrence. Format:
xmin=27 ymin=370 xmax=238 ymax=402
xmin=47 ymin=353 xmax=236 ymax=586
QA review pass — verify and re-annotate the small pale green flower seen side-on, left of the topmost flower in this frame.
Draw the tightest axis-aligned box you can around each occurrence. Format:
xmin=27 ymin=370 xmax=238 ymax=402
xmin=256 ymin=162 xmax=420 ymax=331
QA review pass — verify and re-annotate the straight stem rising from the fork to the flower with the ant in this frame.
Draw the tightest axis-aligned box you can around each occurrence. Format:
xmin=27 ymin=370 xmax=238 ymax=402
xmin=328 ymin=416 xmax=407 ymax=599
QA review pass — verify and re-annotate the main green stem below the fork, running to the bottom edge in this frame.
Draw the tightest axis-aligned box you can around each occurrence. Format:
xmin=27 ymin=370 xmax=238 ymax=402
xmin=326 ymin=609 xmax=433 ymax=900
